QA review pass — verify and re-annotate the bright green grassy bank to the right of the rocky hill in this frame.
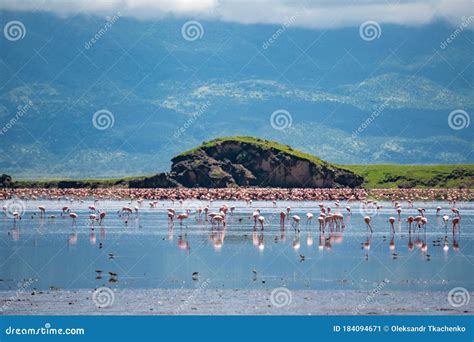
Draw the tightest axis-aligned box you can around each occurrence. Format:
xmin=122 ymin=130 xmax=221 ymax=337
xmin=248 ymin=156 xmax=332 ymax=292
xmin=342 ymin=164 xmax=474 ymax=189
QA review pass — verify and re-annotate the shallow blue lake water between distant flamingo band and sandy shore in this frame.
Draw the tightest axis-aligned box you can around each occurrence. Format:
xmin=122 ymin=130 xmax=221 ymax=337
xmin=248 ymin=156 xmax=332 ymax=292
xmin=0 ymin=201 xmax=474 ymax=291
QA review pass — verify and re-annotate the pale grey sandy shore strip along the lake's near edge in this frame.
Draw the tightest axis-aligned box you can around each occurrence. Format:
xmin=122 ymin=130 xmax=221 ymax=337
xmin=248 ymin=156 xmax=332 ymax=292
xmin=0 ymin=289 xmax=474 ymax=315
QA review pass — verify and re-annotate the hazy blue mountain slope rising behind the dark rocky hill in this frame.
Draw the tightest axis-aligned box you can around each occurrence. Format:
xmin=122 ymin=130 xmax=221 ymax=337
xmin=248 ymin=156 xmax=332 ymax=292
xmin=0 ymin=12 xmax=474 ymax=177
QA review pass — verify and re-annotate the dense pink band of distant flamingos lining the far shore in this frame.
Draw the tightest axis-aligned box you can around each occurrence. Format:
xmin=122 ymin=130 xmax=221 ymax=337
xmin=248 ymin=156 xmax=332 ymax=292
xmin=0 ymin=187 xmax=474 ymax=202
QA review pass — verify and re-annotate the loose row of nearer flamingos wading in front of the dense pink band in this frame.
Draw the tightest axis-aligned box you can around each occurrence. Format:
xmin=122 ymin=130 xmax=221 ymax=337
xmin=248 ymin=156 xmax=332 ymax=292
xmin=3 ymin=191 xmax=461 ymax=255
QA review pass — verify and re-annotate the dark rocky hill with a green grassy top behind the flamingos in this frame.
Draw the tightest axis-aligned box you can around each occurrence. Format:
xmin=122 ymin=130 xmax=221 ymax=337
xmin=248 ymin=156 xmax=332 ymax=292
xmin=130 ymin=137 xmax=364 ymax=188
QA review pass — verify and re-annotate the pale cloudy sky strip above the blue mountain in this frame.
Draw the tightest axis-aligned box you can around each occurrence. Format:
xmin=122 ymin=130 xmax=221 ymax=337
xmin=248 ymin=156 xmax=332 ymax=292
xmin=0 ymin=0 xmax=474 ymax=28
